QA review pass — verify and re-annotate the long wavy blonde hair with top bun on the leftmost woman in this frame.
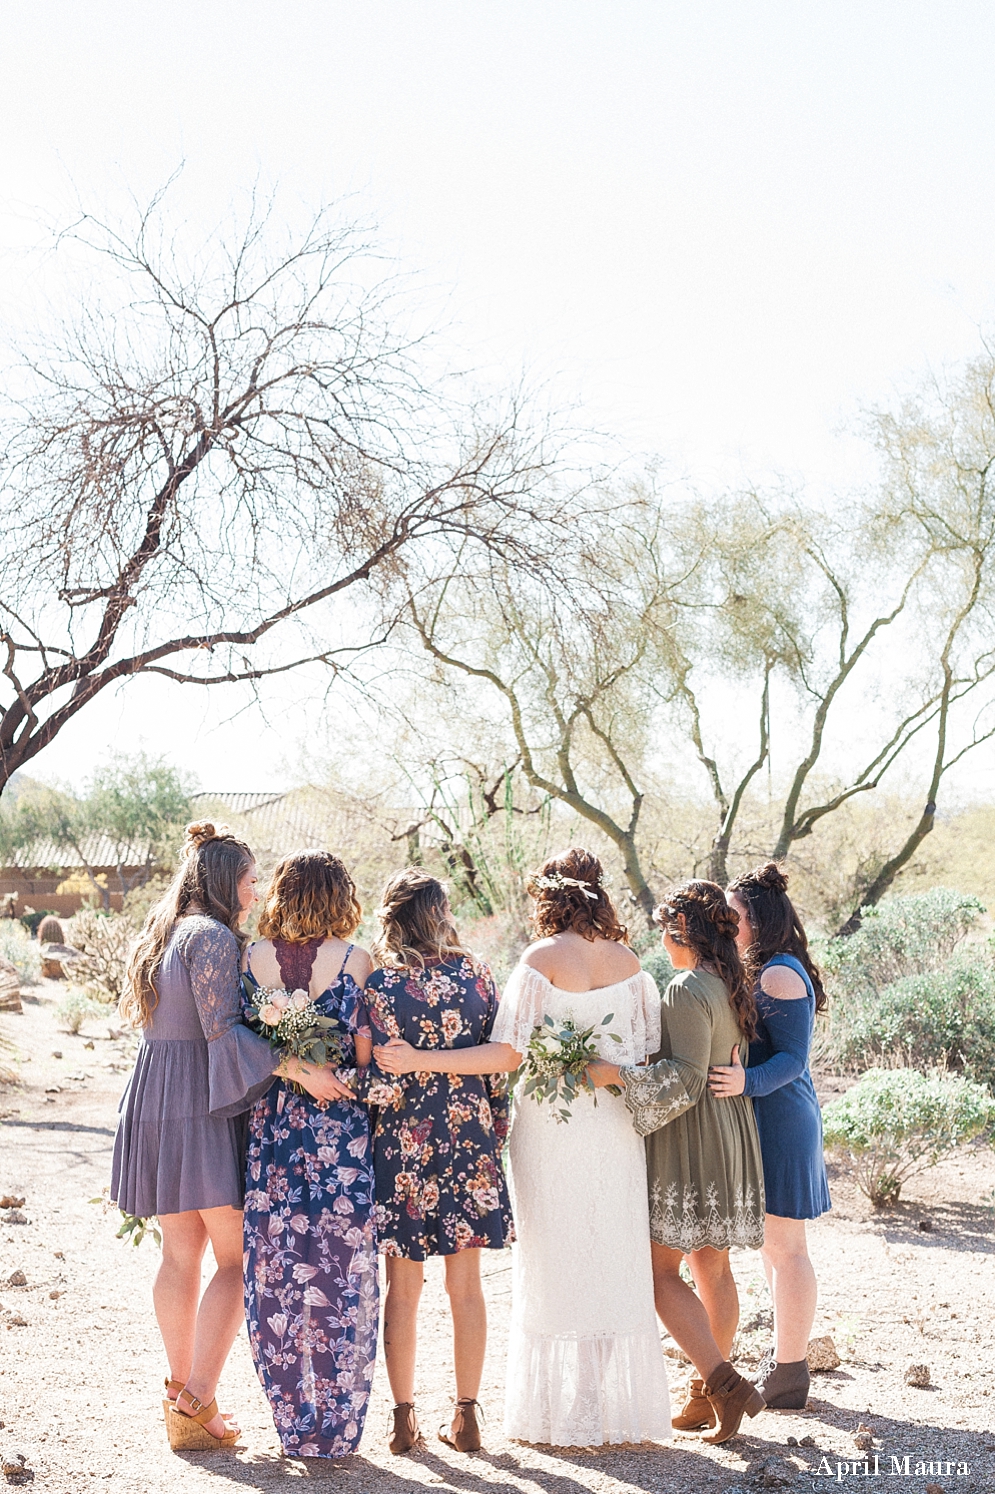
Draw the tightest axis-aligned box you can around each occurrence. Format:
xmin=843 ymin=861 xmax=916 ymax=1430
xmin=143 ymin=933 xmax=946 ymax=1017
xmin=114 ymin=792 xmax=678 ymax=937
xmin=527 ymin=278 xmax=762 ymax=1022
xmin=118 ymin=820 xmax=254 ymax=1026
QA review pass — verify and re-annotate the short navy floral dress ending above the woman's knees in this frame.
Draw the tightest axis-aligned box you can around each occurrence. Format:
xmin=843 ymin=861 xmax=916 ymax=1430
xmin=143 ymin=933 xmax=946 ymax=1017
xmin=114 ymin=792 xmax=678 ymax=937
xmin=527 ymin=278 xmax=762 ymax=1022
xmin=365 ymin=956 xmax=514 ymax=1261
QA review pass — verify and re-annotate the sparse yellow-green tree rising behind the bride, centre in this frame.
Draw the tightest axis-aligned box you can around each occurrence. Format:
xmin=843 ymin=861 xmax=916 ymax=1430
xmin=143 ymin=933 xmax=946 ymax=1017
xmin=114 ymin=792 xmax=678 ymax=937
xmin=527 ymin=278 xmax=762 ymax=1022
xmin=408 ymin=495 xmax=677 ymax=926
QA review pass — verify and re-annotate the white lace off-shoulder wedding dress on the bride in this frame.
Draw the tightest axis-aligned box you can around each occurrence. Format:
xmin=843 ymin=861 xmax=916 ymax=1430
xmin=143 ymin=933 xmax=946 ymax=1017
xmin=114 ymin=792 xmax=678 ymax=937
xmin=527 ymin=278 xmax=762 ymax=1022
xmin=492 ymin=965 xmax=671 ymax=1448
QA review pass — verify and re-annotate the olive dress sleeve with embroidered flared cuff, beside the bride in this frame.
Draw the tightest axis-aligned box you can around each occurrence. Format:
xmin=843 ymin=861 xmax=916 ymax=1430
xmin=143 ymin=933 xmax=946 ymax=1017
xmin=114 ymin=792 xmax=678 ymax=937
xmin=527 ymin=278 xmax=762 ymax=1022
xmin=619 ymin=982 xmax=711 ymax=1135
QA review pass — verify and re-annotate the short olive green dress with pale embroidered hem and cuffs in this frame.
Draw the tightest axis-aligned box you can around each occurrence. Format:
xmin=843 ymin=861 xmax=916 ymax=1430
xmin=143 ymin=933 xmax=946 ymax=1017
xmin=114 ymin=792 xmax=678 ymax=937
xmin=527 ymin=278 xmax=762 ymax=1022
xmin=622 ymin=970 xmax=763 ymax=1252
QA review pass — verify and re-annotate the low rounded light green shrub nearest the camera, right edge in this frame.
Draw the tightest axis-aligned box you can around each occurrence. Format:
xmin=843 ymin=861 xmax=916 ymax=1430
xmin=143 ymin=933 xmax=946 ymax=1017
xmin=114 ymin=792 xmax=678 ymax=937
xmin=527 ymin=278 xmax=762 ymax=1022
xmin=823 ymin=1068 xmax=995 ymax=1209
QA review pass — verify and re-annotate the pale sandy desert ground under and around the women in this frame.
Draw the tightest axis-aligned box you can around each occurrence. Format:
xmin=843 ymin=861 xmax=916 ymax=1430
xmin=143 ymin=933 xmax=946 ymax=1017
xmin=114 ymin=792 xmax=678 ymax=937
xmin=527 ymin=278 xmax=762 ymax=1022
xmin=0 ymin=982 xmax=995 ymax=1494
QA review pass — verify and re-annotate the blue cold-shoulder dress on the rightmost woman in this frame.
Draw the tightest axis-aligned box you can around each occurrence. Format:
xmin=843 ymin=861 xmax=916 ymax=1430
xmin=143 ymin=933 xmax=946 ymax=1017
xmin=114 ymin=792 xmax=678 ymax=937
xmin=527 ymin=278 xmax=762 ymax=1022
xmin=744 ymin=955 xmax=832 ymax=1219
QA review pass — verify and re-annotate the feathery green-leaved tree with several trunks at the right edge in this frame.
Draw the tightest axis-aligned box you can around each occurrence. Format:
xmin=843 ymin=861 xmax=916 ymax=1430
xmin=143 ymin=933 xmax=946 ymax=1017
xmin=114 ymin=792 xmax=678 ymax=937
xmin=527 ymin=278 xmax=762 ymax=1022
xmin=660 ymin=370 xmax=995 ymax=932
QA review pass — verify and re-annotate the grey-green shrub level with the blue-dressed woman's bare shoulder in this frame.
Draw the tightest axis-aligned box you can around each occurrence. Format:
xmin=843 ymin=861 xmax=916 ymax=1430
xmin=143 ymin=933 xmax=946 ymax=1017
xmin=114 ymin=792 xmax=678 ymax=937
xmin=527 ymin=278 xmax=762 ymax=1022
xmin=823 ymin=887 xmax=985 ymax=998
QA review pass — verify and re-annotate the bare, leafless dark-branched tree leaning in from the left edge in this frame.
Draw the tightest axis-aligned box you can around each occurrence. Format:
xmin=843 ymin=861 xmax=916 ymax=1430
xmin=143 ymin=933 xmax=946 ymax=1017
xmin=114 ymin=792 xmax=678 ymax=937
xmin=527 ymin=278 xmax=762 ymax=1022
xmin=0 ymin=194 xmax=556 ymax=790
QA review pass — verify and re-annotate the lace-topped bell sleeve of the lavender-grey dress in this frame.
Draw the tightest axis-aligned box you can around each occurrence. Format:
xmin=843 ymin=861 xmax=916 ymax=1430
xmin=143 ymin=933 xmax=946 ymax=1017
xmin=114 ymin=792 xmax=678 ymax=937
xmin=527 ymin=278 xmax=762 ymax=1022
xmin=179 ymin=920 xmax=278 ymax=1119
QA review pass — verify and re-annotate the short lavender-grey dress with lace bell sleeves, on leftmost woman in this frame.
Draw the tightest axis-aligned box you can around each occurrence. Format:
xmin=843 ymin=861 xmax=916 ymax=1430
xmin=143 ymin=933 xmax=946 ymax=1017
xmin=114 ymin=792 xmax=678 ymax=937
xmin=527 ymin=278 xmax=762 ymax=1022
xmin=111 ymin=914 xmax=275 ymax=1218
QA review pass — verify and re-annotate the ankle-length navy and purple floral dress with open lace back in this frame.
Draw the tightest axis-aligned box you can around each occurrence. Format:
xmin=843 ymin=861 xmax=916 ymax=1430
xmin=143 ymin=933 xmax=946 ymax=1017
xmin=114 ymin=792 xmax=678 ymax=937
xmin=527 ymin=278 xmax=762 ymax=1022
xmin=245 ymin=940 xmax=379 ymax=1458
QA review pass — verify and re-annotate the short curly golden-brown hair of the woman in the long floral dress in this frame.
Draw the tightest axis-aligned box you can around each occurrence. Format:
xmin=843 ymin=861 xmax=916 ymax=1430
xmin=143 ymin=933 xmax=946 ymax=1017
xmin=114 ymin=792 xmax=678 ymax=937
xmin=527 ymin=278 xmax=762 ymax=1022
xmin=257 ymin=850 xmax=363 ymax=944
